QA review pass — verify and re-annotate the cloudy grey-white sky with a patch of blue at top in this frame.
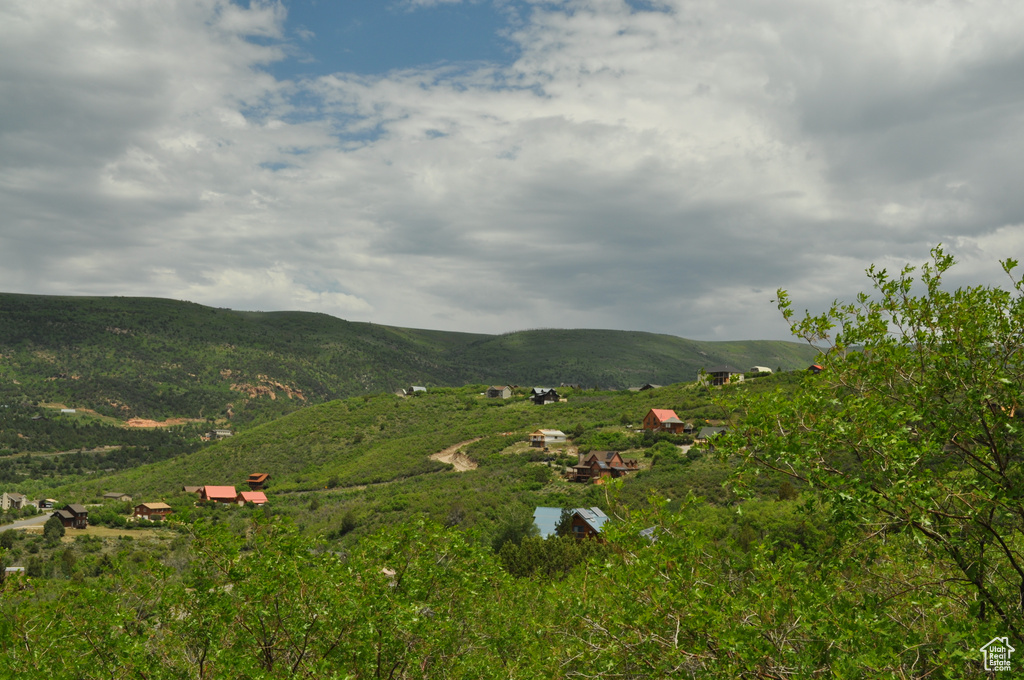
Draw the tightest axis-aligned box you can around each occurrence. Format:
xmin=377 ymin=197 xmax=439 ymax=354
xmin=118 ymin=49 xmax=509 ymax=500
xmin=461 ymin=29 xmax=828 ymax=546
xmin=0 ymin=0 xmax=1024 ymax=340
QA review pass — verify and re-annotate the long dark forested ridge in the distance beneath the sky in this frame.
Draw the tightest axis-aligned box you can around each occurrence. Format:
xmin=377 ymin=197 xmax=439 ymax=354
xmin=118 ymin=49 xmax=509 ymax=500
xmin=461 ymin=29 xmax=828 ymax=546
xmin=0 ymin=294 xmax=814 ymax=424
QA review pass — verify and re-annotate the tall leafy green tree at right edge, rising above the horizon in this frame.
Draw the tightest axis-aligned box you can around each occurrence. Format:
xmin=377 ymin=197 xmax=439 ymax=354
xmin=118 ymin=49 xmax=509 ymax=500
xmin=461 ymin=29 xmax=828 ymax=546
xmin=732 ymin=246 xmax=1024 ymax=638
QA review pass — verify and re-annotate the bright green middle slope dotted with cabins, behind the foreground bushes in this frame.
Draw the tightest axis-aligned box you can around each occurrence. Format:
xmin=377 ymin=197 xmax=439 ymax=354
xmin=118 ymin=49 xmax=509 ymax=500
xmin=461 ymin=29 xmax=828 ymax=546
xmin=40 ymin=373 xmax=800 ymax=534
